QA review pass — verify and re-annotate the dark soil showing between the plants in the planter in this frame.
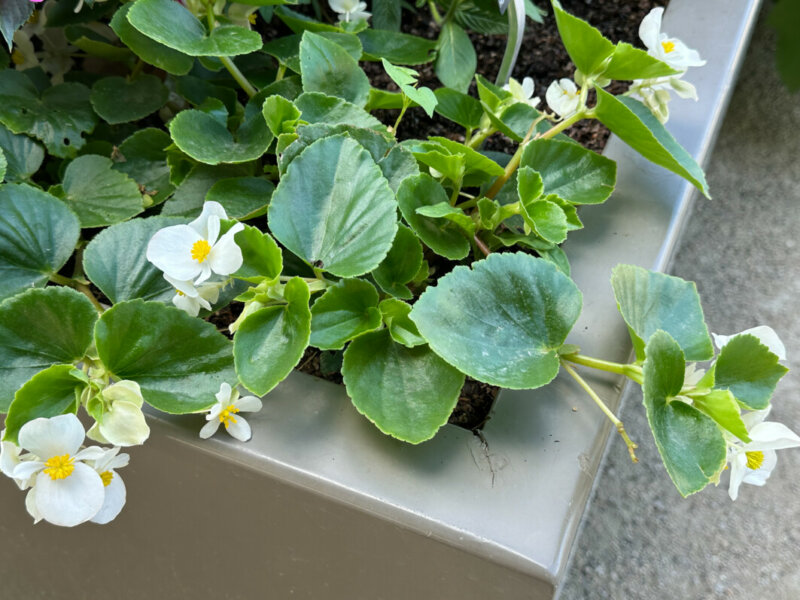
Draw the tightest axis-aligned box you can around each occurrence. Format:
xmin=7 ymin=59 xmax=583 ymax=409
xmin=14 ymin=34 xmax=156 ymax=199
xmin=258 ymin=0 xmax=667 ymax=431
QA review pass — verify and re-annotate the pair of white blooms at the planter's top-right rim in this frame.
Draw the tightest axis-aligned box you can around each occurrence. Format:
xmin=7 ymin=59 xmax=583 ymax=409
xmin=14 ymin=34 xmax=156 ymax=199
xmin=629 ymin=8 xmax=706 ymax=123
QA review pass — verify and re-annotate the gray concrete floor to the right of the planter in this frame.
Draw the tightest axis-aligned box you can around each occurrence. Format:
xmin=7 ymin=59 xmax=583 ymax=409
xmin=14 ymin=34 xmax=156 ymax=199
xmin=560 ymin=5 xmax=800 ymax=600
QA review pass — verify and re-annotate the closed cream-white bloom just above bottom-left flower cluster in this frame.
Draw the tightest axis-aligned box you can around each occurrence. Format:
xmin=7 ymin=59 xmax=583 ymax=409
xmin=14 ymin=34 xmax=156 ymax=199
xmin=86 ymin=380 xmax=150 ymax=446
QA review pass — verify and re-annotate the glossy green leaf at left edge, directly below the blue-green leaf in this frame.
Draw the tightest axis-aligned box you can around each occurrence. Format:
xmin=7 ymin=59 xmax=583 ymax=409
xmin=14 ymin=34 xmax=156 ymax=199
xmin=0 ymin=287 xmax=97 ymax=412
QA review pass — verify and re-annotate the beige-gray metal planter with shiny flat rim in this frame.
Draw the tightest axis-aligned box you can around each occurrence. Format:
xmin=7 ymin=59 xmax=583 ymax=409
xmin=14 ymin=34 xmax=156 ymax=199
xmin=0 ymin=0 xmax=759 ymax=599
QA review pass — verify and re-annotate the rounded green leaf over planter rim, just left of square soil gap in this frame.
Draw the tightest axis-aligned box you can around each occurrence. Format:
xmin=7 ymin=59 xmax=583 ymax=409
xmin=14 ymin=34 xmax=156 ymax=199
xmin=342 ymin=330 xmax=464 ymax=444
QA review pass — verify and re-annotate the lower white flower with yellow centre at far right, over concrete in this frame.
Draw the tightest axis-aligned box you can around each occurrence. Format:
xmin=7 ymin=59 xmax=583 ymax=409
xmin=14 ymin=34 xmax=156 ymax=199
xmin=728 ymin=407 xmax=800 ymax=500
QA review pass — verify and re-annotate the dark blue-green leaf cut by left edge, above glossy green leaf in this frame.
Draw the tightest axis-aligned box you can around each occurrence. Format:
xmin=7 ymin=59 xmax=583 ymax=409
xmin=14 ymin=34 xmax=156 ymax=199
xmin=0 ymin=184 xmax=80 ymax=300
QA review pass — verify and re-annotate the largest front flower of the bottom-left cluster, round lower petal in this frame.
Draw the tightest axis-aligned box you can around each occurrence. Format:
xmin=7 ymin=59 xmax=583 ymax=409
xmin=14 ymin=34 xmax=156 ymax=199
xmin=13 ymin=413 xmax=105 ymax=527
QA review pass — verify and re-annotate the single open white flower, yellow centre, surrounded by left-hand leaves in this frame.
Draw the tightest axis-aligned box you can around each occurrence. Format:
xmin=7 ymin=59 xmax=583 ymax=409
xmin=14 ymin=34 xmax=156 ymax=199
xmin=146 ymin=202 xmax=244 ymax=285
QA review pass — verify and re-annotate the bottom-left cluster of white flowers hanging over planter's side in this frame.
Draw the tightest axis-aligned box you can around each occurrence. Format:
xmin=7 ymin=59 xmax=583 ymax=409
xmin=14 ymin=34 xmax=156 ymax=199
xmin=0 ymin=414 xmax=128 ymax=527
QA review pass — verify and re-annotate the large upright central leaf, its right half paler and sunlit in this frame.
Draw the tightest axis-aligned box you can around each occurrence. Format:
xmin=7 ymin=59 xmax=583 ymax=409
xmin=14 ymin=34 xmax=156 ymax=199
xmin=268 ymin=135 xmax=397 ymax=277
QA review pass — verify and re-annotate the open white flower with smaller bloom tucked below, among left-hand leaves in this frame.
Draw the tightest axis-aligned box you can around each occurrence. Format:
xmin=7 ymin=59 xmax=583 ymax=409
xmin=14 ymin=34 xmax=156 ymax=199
xmin=147 ymin=202 xmax=244 ymax=317
